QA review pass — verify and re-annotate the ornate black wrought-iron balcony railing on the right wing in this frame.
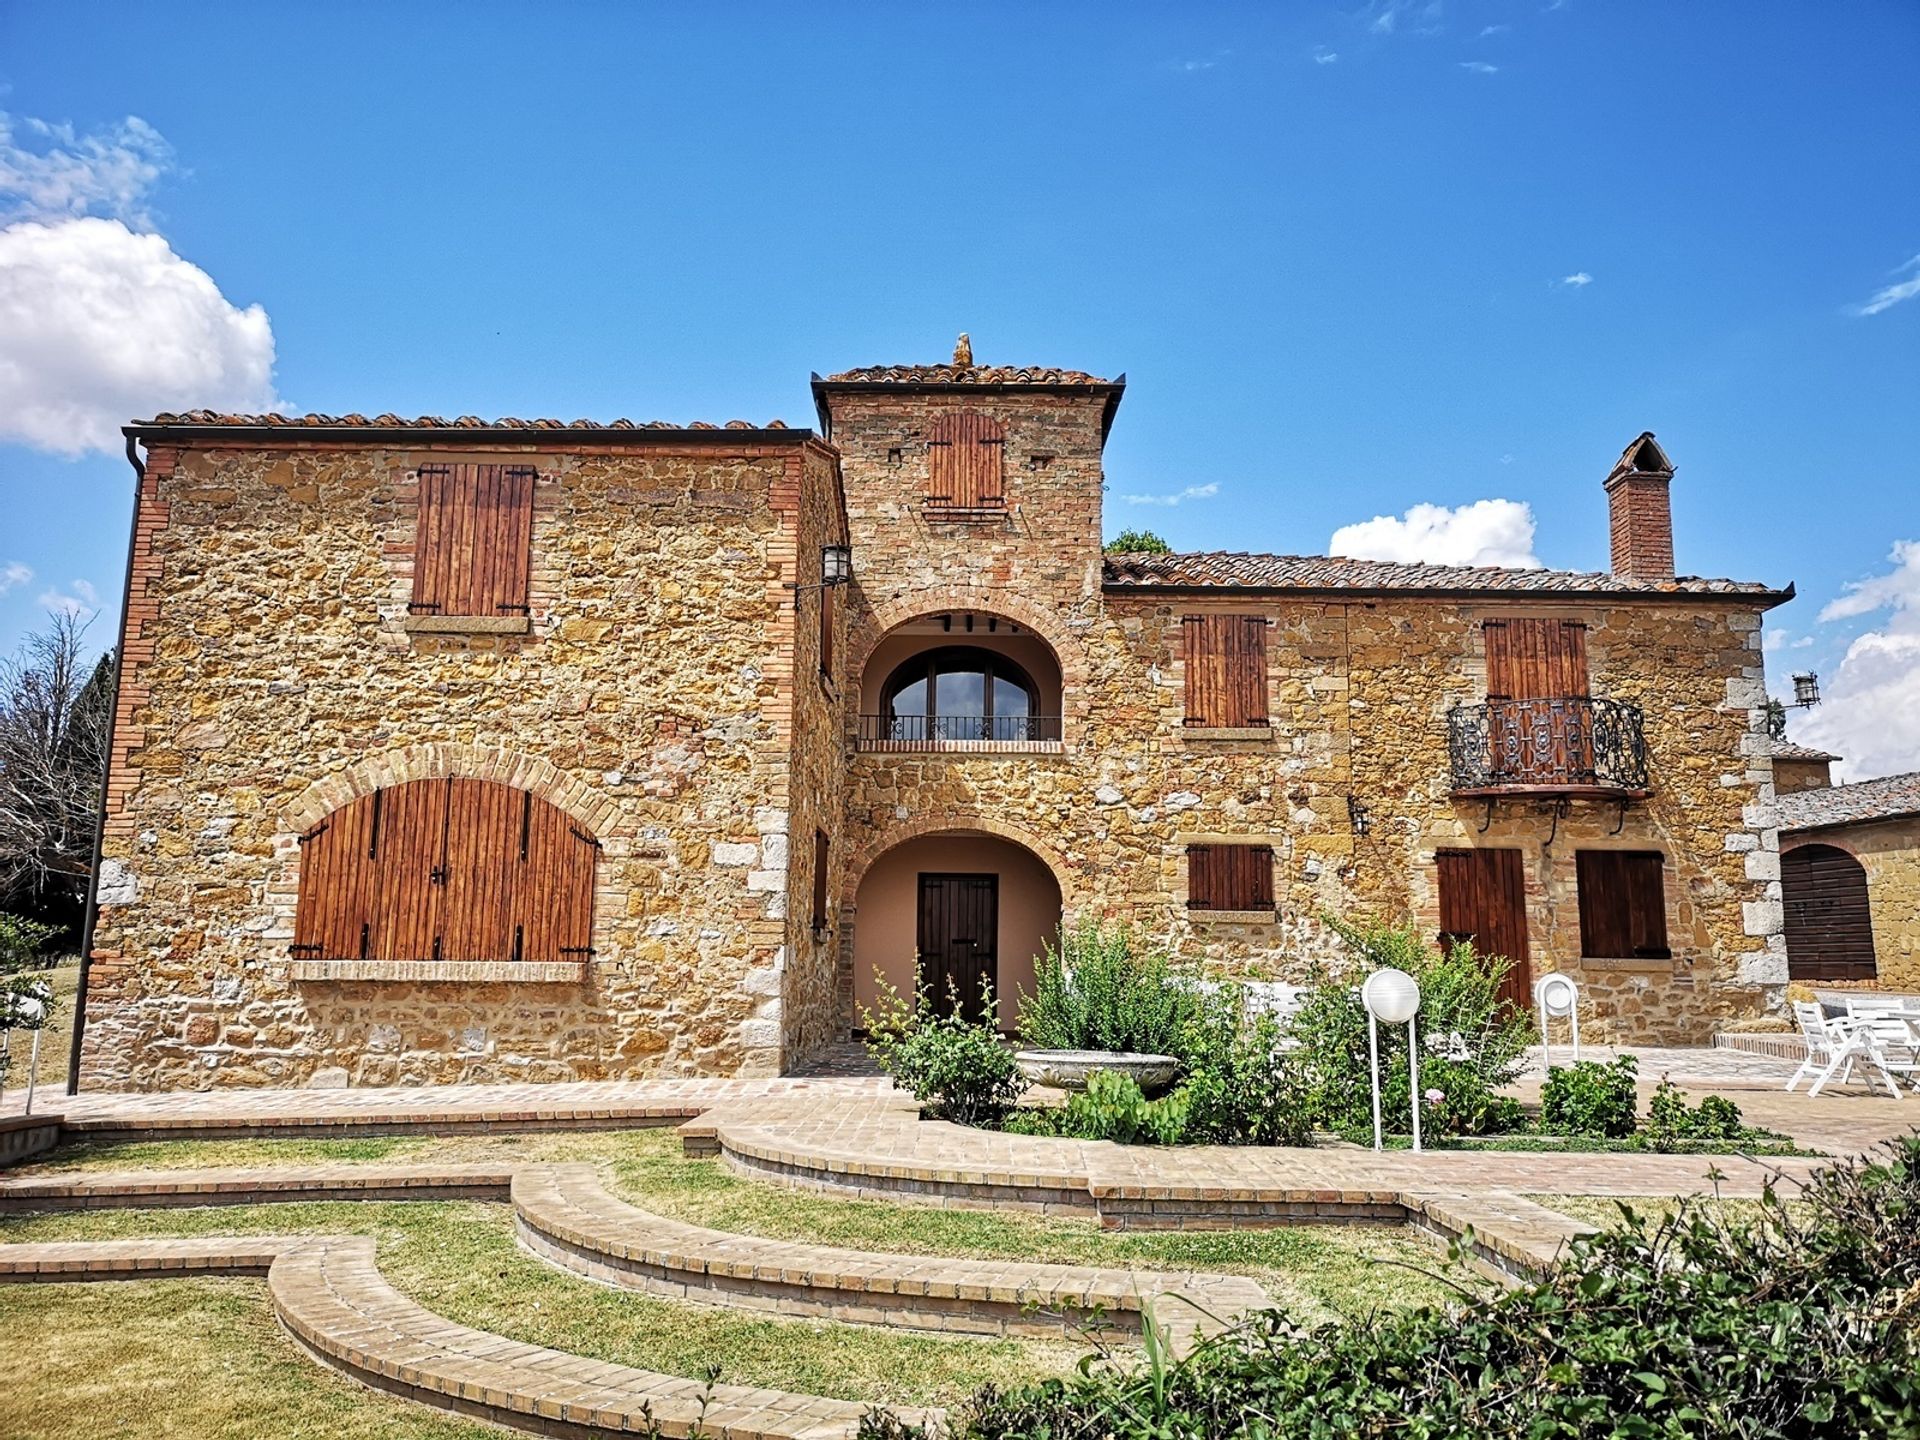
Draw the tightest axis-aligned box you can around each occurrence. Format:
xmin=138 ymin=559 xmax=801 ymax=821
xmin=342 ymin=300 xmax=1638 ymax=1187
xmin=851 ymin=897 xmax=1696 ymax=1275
xmin=1446 ymin=695 xmax=1647 ymax=797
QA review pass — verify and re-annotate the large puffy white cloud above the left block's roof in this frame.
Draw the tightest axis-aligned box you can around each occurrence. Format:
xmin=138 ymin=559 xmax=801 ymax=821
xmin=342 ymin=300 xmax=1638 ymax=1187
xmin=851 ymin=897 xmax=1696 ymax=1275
xmin=0 ymin=219 xmax=276 ymax=455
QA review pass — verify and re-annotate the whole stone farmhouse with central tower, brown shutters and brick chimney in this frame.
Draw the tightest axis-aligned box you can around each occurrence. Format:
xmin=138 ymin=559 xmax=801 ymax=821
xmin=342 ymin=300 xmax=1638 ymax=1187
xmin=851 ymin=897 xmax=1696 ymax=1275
xmin=79 ymin=355 xmax=1791 ymax=1089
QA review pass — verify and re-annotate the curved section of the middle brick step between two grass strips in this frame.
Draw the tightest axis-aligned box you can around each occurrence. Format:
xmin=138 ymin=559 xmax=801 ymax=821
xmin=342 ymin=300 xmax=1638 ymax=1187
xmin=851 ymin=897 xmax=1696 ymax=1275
xmin=513 ymin=1165 xmax=1271 ymax=1346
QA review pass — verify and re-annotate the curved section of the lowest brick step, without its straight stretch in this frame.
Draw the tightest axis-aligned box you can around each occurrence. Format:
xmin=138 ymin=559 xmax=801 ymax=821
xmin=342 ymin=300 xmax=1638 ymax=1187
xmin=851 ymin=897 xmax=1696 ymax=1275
xmin=267 ymin=1236 xmax=918 ymax=1440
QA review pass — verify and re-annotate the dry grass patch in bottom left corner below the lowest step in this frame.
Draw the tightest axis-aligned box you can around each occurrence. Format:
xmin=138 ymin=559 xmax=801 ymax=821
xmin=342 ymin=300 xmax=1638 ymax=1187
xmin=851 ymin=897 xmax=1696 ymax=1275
xmin=0 ymin=1279 xmax=501 ymax=1440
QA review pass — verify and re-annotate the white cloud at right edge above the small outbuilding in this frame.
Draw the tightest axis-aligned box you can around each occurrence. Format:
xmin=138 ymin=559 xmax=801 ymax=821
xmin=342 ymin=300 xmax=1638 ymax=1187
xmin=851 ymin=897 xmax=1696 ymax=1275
xmin=1793 ymin=540 xmax=1920 ymax=780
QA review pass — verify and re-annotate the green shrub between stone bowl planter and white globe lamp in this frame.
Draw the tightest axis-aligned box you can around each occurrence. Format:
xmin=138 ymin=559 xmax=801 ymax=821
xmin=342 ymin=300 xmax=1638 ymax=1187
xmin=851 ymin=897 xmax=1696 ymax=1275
xmin=1177 ymin=985 xmax=1313 ymax=1144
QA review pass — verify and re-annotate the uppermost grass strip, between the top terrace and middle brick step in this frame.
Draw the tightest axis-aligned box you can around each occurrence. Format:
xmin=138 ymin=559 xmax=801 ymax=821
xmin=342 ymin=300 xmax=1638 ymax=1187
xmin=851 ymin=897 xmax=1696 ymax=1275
xmin=19 ymin=1129 xmax=1465 ymax=1321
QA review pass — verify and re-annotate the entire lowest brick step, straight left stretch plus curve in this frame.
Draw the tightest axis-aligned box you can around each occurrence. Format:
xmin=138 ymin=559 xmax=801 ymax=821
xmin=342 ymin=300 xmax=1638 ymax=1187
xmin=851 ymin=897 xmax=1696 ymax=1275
xmin=0 ymin=1236 xmax=925 ymax=1440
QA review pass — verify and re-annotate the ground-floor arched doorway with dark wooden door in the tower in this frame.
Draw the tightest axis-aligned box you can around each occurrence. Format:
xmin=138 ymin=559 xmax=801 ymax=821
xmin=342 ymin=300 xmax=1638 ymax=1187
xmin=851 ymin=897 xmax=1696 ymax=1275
xmin=852 ymin=829 xmax=1060 ymax=1031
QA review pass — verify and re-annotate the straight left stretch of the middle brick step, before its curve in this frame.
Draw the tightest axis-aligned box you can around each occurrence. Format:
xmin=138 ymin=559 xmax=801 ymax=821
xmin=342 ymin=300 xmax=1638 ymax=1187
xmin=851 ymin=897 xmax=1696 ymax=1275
xmin=0 ymin=1162 xmax=513 ymax=1215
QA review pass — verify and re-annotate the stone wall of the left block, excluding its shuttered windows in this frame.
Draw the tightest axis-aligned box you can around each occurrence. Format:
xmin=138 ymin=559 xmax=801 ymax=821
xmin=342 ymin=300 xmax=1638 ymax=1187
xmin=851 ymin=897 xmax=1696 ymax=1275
xmin=83 ymin=432 xmax=831 ymax=1089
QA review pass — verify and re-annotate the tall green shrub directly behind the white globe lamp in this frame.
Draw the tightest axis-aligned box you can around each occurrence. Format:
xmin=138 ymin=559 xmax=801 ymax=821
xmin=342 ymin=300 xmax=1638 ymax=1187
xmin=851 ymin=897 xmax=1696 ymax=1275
xmin=1292 ymin=918 xmax=1532 ymax=1137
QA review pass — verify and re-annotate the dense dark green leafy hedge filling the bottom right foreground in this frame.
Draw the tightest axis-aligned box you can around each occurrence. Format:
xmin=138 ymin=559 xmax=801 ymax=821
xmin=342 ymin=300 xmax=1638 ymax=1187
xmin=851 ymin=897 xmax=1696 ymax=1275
xmin=860 ymin=1137 xmax=1920 ymax=1440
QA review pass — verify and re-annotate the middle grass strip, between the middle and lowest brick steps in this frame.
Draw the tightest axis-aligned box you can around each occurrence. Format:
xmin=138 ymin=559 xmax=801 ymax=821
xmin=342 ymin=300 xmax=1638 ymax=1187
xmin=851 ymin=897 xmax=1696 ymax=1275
xmin=0 ymin=1202 xmax=1083 ymax=1413
